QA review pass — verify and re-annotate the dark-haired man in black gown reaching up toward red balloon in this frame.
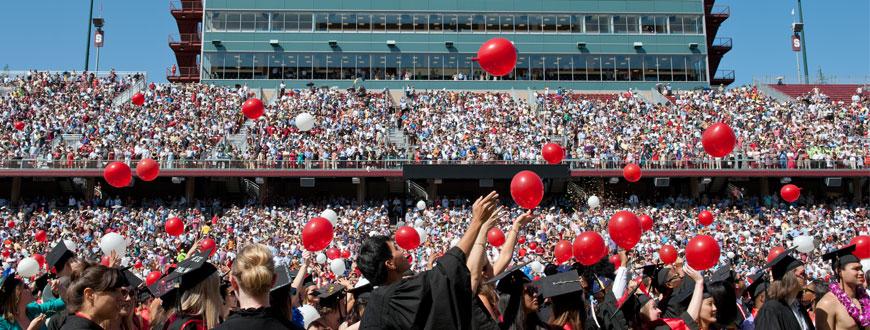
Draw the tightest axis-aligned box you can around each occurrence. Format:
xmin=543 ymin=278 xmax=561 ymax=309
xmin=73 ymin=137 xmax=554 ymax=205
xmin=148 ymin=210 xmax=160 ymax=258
xmin=357 ymin=192 xmax=498 ymax=330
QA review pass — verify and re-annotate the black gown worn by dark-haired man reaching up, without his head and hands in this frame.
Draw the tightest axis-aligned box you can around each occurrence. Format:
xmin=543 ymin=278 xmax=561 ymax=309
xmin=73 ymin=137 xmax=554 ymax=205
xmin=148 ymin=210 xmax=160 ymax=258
xmin=360 ymin=247 xmax=472 ymax=330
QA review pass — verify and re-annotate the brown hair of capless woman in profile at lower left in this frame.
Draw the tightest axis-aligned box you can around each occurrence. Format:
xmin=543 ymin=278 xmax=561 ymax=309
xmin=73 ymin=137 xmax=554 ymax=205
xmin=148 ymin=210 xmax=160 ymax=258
xmin=63 ymin=265 xmax=127 ymax=312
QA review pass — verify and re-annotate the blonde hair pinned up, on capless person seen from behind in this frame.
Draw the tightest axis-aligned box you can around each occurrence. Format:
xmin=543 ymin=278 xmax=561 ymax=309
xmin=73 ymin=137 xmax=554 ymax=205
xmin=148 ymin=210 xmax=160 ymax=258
xmin=233 ymin=244 xmax=275 ymax=297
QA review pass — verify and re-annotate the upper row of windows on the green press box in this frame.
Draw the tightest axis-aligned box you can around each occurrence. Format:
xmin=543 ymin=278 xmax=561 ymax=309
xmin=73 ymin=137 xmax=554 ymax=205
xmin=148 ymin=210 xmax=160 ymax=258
xmin=206 ymin=11 xmax=704 ymax=34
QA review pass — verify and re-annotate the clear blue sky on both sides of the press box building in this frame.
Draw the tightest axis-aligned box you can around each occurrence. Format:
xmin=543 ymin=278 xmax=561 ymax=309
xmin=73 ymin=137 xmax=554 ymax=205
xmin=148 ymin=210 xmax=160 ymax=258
xmin=0 ymin=0 xmax=870 ymax=83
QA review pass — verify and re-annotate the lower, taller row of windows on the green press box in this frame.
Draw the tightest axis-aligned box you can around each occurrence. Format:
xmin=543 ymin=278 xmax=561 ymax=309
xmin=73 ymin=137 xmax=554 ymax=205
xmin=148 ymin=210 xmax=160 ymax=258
xmin=203 ymin=52 xmax=707 ymax=81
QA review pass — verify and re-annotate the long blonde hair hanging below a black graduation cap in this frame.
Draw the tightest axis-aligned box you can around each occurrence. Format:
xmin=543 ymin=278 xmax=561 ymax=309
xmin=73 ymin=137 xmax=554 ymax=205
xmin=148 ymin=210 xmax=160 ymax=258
xmin=181 ymin=273 xmax=223 ymax=329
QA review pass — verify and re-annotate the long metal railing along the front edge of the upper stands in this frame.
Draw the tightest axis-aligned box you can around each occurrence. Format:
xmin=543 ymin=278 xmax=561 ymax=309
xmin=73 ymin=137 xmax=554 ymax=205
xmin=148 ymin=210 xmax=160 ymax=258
xmin=0 ymin=158 xmax=870 ymax=171
